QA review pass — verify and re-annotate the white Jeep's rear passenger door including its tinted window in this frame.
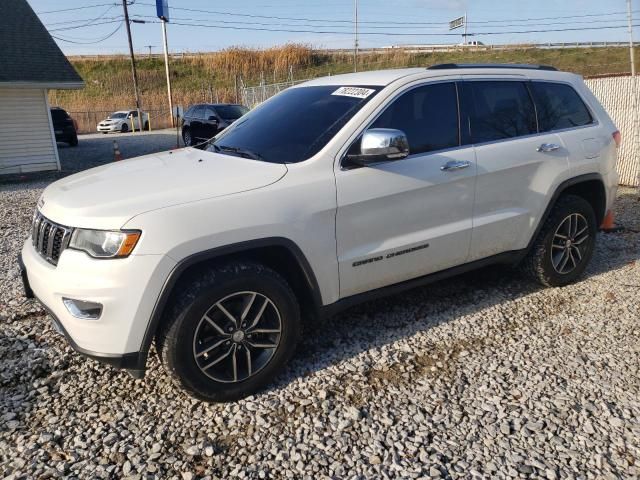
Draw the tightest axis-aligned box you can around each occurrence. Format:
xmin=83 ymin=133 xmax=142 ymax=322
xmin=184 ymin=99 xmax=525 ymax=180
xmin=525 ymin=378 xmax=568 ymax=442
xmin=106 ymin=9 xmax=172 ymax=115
xmin=461 ymin=77 xmax=568 ymax=261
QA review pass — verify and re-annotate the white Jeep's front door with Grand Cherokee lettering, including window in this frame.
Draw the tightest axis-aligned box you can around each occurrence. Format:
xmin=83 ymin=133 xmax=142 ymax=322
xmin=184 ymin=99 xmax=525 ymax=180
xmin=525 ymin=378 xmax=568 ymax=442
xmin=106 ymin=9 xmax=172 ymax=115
xmin=336 ymin=82 xmax=476 ymax=298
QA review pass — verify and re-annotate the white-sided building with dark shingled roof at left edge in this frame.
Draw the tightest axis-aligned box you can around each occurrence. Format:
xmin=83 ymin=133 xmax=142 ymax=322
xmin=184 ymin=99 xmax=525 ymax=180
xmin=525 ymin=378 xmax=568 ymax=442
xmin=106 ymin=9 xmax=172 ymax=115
xmin=0 ymin=0 xmax=84 ymax=175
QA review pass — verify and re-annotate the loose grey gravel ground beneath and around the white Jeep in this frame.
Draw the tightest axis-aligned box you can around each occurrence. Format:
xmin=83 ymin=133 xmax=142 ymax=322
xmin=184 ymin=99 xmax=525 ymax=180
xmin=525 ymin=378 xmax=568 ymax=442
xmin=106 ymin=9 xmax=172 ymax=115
xmin=0 ymin=183 xmax=640 ymax=479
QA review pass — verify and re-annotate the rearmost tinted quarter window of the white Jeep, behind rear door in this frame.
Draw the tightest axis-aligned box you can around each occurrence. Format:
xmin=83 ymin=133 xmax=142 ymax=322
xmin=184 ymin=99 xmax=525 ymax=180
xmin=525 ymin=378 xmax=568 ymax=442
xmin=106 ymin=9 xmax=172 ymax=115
xmin=531 ymin=82 xmax=593 ymax=132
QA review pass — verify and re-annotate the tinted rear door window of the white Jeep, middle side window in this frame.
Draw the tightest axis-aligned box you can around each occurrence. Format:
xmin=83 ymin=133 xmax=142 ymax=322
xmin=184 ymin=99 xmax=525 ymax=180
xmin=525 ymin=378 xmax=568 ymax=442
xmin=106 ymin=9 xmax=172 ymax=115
xmin=465 ymin=81 xmax=538 ymax=143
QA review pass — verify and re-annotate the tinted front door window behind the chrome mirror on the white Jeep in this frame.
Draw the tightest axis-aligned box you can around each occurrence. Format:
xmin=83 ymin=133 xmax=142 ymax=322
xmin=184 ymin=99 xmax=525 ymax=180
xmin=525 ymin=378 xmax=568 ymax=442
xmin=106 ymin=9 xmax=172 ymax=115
xmin=370 ymin=83 xmax=459 ymax=154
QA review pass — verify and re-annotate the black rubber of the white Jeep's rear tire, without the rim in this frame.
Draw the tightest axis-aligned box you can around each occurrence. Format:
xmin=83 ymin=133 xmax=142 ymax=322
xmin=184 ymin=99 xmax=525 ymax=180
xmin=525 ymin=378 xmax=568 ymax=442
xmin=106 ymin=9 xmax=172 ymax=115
xmin=541 ymin=197 xmax=598 ymax=286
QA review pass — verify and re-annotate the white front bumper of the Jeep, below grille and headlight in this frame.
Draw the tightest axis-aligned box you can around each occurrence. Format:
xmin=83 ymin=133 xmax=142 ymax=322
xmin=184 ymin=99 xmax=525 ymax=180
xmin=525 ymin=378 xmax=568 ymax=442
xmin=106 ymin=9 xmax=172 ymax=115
xmin=18 ymin=239 xmax=175 ymax=376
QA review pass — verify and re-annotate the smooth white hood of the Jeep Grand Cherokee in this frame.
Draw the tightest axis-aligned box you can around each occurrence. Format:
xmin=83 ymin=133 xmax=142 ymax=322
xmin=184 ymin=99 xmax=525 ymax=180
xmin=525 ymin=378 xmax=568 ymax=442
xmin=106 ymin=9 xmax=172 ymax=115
xmin=39 ymin=148 xmax=287 ymax=229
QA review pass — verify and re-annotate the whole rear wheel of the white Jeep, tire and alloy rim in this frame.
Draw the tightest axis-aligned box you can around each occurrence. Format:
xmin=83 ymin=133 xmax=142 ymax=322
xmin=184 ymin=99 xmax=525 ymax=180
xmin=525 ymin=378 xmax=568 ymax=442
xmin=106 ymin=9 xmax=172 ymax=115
xmin=522 ymin=195 xmax=598 ymax=287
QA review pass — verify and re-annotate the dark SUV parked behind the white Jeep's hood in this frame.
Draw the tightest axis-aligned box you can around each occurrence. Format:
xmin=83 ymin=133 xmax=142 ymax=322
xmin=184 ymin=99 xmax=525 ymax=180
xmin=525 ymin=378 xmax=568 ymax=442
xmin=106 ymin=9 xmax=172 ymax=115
xmin=182 ymin=103 xmax=249 ymax=147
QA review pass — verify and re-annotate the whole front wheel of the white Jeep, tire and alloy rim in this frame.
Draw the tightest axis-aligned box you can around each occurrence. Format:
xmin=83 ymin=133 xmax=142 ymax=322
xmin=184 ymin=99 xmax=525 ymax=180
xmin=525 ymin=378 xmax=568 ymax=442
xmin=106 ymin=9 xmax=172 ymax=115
xmin=156 ymin=262 xmax=301 ymax=402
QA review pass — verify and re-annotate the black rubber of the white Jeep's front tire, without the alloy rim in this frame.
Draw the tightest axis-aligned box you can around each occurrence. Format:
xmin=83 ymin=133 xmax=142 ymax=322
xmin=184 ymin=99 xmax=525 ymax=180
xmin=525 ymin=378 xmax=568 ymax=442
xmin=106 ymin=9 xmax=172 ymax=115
xmin=168 ymin=274 xmax=300 ymax=401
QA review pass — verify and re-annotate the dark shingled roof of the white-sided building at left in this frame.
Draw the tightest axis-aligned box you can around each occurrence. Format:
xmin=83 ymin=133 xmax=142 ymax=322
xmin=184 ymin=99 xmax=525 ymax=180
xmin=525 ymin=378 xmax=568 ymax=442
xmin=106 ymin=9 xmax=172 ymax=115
xmin=0 ymin=0 xmax=84 ymax=88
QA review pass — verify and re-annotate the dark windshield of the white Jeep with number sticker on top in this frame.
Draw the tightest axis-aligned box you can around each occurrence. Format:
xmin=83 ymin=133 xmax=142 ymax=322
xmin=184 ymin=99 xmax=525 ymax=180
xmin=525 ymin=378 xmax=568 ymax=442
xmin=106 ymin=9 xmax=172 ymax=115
xmin=207 ymin=85 xmax=379 ymax=163
